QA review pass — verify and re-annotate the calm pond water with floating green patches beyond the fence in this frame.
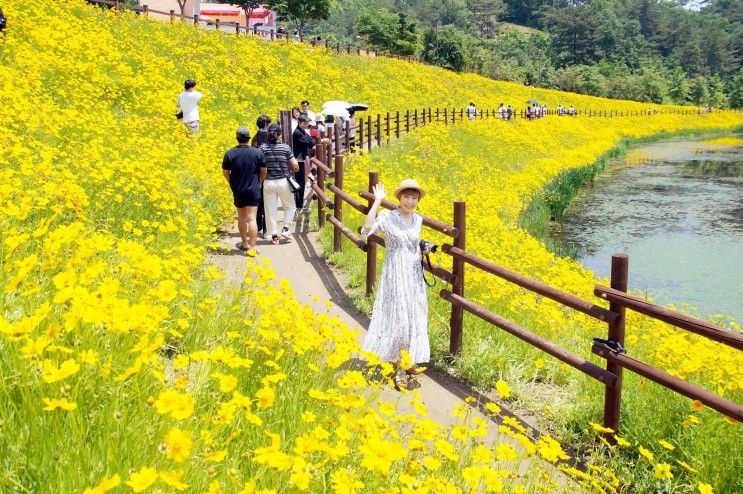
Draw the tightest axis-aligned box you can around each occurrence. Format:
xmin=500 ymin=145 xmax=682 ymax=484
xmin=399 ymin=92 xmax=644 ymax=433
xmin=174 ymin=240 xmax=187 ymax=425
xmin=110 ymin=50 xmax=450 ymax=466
xmin=550 ymin=136 xmax=743 ymax=322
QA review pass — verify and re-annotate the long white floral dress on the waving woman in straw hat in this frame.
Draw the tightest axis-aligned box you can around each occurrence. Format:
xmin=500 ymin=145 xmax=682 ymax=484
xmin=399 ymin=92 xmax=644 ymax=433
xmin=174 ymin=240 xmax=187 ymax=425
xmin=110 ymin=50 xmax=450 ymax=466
xmin=362 ymin=210 xmax=431 ymax=364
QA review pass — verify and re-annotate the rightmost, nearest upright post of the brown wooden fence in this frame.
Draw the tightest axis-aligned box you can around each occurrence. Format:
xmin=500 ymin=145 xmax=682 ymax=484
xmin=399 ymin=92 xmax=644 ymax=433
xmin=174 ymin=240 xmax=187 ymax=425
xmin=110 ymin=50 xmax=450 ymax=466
xmin=604 ymin=254 xmax=629 ymax=441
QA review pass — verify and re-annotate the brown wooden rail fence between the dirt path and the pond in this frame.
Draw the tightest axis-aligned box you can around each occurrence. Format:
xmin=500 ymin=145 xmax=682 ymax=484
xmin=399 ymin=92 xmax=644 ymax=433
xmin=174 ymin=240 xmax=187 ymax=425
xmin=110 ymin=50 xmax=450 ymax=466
xmin=296 ymin=109 xmax=743 ymax=432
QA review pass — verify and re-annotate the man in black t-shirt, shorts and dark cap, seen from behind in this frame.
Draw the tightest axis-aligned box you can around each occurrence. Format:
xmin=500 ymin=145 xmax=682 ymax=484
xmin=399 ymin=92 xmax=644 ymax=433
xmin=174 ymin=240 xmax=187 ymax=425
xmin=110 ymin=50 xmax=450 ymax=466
xmin=222 ymin=127 xmax=266 ymax=257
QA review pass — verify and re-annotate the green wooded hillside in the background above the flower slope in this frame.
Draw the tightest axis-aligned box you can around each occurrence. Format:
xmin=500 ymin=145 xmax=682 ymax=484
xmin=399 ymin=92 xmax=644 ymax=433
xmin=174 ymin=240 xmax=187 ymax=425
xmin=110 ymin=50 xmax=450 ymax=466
xmin=294 ymin=0 xmax=743 ymax=108
